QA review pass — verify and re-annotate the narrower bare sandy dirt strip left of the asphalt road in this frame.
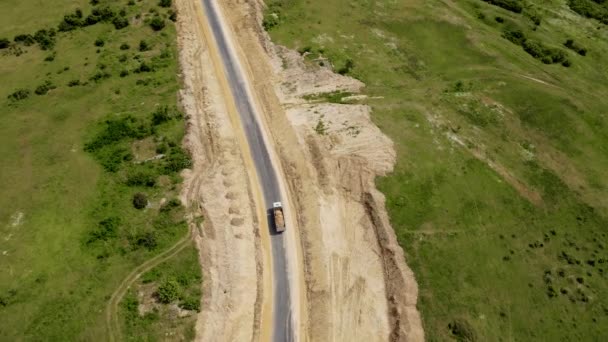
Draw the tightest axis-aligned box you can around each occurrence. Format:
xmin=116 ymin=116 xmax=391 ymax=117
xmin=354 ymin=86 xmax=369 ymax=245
xmin=175 ymin=0 xmax=263 ymax=341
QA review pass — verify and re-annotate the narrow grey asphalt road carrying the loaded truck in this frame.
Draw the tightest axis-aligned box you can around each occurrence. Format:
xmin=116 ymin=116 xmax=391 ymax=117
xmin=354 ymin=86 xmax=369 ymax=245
xmin=201 ymin=0 xmax=293 ymax=342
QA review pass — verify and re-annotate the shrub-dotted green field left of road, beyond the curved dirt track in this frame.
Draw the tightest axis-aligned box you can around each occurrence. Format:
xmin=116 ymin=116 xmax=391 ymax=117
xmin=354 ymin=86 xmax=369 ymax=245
xmin=0 ymin=0 xmax=197 ymax=341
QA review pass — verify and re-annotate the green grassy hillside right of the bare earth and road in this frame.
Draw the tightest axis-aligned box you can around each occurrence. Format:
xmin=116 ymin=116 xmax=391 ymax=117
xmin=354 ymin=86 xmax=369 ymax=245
xmin=264 ymin=0 xmax=608 ymax=341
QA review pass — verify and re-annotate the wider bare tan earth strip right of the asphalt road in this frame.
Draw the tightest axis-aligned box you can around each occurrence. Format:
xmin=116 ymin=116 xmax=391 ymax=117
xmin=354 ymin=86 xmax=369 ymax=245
xmin=216 ymin=0 xmax=424 ymax=341
